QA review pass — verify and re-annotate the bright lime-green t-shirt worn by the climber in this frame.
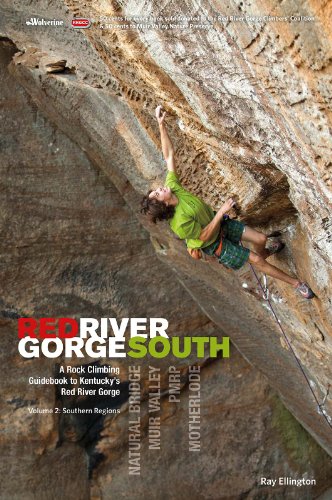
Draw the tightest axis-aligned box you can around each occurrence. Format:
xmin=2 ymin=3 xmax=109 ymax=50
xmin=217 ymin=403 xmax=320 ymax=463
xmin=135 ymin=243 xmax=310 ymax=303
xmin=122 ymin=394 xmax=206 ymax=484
xmin=165 ymin=172 xmax=218 ymax=248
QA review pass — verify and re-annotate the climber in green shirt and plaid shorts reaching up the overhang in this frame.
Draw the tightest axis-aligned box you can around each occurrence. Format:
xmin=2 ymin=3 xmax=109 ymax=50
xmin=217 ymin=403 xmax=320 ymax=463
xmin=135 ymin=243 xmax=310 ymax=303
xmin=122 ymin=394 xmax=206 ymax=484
xmin=141 ymin=106 xmax=315 ymax=299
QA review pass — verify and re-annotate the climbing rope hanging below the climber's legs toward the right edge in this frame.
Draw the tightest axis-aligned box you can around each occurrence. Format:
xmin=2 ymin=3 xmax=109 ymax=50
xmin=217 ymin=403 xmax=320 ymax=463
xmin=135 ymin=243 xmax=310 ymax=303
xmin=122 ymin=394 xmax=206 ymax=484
xmin=249 ymin=263 xmax=332 ymax=429
